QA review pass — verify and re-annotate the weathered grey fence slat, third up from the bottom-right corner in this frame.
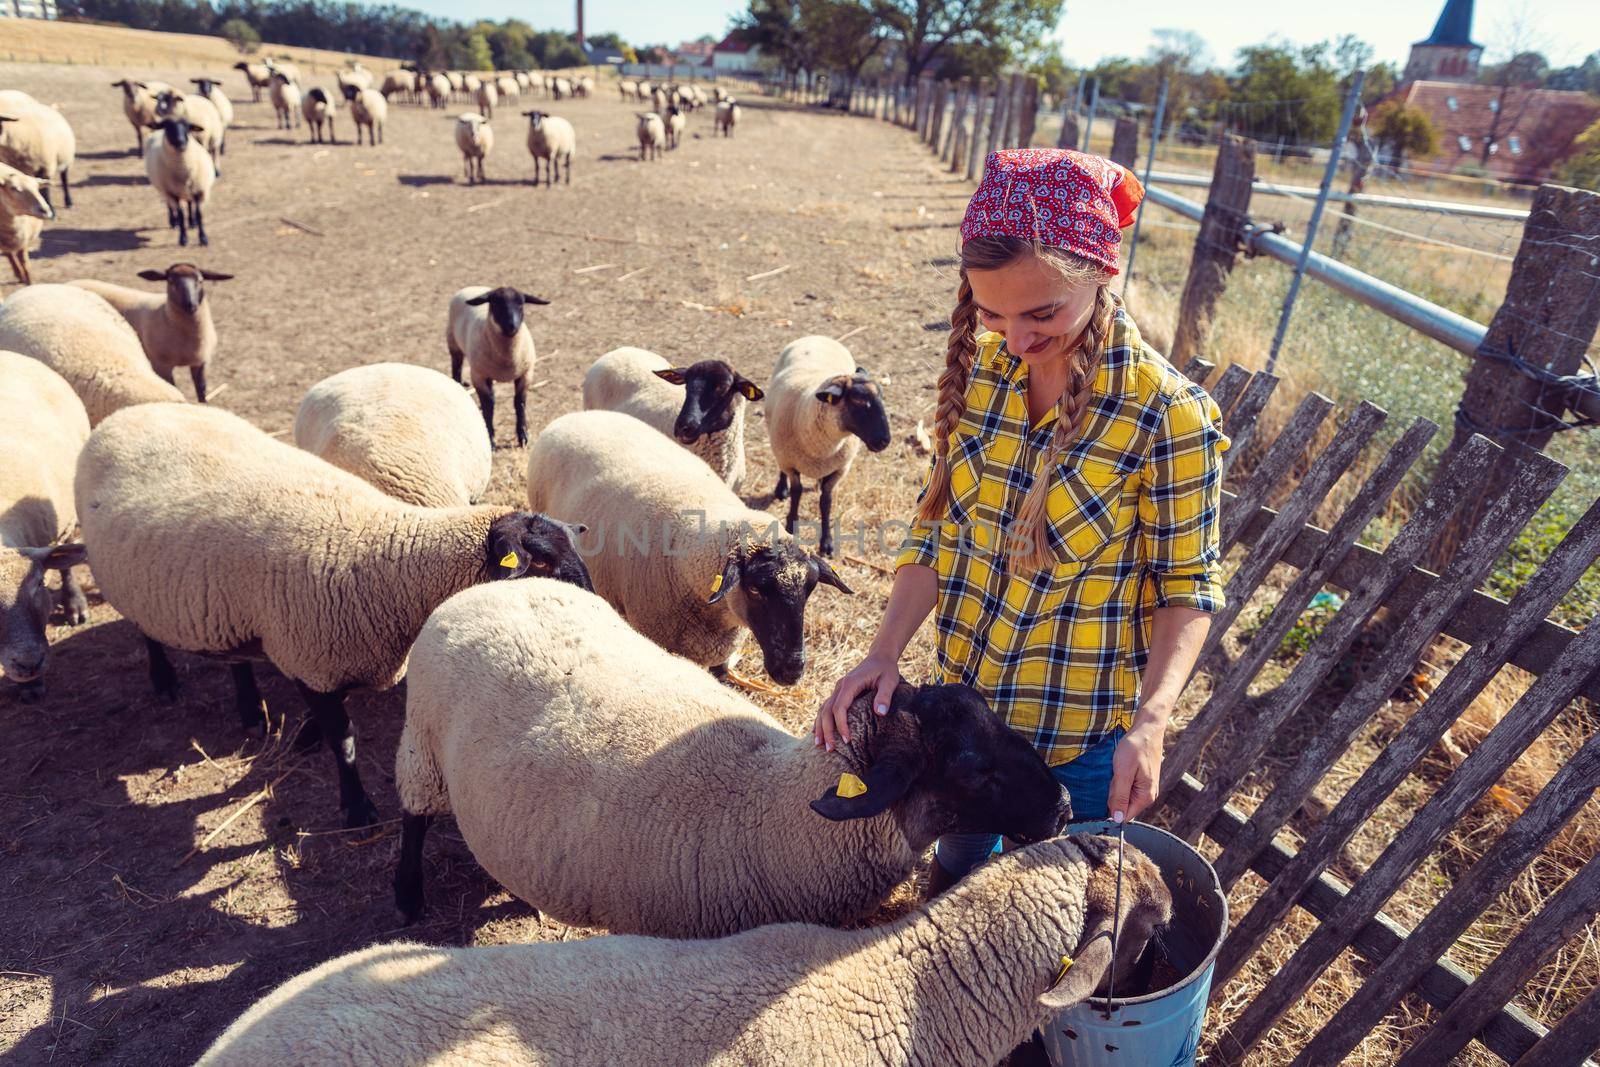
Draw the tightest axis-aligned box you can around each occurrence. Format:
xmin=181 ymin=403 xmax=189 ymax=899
xmin=1294 ymin=729 xmax=1600 ymax=1067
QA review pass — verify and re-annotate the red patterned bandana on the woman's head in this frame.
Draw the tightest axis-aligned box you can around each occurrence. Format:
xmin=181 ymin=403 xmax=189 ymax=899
xmin=962 ymin=149 xmax=1144 ymax=274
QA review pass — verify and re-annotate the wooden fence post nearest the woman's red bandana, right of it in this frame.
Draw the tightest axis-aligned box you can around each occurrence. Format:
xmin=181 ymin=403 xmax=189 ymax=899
xmin=1170 ymin=134 xmax=1254 ymax=367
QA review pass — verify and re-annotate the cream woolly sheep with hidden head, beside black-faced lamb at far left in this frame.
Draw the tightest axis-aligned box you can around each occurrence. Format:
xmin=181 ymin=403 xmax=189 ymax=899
xmin=0 ymin=285 xmax=184 ymax=426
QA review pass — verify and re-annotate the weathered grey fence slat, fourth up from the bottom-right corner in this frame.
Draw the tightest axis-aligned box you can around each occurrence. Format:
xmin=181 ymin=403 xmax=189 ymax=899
xmin=1209 ymin=601 xmax=1600 ymax=1059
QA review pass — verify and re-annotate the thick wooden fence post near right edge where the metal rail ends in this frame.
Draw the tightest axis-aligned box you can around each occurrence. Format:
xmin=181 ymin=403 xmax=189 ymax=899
xmin=1430 ymin=186 xmax=1600 ymax=563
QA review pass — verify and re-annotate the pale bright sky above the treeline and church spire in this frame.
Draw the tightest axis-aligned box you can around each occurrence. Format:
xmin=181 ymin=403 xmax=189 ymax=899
xmin=397 ymin=0 xmax=1600 ymax=66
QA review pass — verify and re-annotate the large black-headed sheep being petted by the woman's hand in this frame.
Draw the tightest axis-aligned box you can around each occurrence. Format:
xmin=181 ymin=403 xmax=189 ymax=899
xmin=395 ymin=572 xmax=1070 ymax=937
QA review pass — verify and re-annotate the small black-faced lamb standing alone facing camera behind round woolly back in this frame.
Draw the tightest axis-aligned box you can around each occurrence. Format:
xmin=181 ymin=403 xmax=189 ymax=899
xmin=445 ymin=285 xmax=550 ymax=448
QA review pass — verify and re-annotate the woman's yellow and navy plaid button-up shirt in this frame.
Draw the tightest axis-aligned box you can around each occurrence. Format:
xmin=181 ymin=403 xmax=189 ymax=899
xmin=896 ymin=309 xmax=1229 ymax=766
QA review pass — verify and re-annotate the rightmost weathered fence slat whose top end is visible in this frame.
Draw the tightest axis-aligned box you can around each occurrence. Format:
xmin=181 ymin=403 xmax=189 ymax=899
xmin=1213 ymin=453 xmax=1566 ymax=886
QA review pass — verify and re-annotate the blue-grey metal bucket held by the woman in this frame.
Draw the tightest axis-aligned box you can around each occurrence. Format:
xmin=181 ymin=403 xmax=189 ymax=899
xmin=1043 ymin=821 xmax=1227 ymax=1067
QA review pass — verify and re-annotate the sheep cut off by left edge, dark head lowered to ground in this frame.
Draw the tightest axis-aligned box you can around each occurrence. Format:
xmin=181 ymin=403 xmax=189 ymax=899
xmin=0 ymin=351 xmax=90 ymax=701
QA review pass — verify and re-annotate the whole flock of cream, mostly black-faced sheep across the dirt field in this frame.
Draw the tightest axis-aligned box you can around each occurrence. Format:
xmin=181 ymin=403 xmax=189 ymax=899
xmin=0 ymin=56 xmax=1171 ymax=1064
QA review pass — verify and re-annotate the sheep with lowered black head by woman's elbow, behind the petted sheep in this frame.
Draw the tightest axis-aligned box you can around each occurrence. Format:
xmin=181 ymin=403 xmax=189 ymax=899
xmin=528 ymin=411 xmax=851 ymax=686
